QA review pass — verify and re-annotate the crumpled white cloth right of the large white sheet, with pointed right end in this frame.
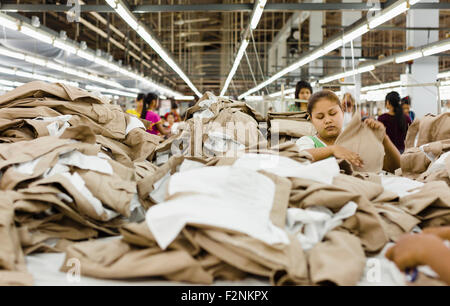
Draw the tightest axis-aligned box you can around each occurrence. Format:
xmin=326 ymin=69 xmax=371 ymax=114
xmin=286 ymin=201 xmax=358 ymax=250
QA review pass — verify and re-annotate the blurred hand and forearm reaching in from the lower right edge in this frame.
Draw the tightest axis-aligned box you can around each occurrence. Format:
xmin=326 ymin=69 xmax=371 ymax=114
xmin=386 ymin=226 xmax=450 ymax=285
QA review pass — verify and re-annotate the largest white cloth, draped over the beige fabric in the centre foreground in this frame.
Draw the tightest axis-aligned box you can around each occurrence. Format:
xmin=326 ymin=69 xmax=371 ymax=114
xmin=146 ymin=166 xmax=289 ymax=249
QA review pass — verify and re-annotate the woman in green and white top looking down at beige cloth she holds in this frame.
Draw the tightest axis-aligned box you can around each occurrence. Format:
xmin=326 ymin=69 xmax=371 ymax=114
xmin=296 ymin=90 xmax=400 ymax=172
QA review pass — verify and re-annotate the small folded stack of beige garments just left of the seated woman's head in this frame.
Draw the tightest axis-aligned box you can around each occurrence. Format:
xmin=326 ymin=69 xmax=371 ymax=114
xmin=267 ymin=111 xmax=316 ymax=146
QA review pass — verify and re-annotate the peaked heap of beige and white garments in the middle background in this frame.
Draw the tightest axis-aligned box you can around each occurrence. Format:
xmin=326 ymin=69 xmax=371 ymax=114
xmin=155 ymin=92 xmax=267 ymax=166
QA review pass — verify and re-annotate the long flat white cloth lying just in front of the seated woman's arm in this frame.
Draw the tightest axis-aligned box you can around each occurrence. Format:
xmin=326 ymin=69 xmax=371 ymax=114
xmin=233 ymin=153 xmax=339 ymax=184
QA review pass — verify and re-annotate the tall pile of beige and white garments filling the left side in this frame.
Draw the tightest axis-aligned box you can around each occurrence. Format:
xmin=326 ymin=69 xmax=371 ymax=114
xmin=0 ymin=82 xmax=161 ymax=284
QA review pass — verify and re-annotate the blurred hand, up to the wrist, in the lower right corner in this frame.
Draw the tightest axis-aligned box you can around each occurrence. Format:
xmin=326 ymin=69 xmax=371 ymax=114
xmin=386 ymin=234 xmax=443 ymax=271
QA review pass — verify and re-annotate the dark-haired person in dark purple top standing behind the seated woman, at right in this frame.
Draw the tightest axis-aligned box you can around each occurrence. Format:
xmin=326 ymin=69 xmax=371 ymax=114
xmin=378 ymin=91 xmax=411 ymax=153
